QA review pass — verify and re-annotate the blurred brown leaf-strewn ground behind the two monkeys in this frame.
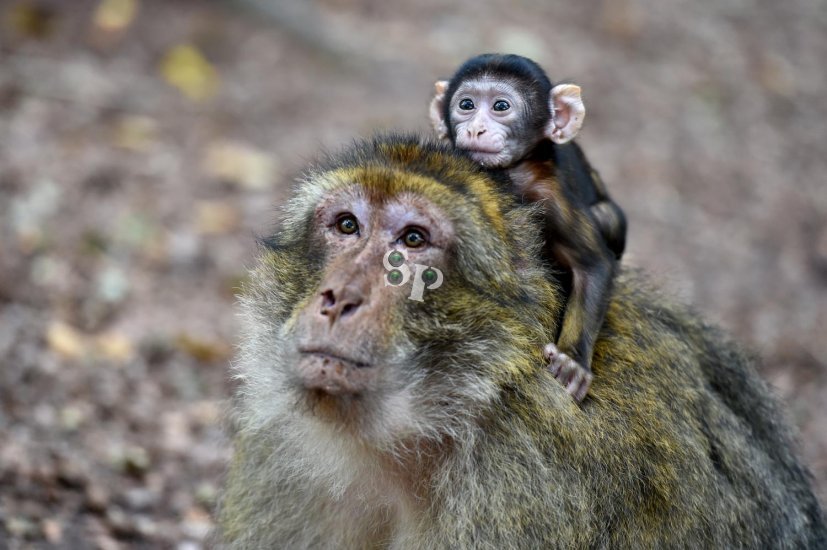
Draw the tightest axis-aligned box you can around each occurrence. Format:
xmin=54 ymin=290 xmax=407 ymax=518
xmin=0 ymin=0 xmax=827 ymax=550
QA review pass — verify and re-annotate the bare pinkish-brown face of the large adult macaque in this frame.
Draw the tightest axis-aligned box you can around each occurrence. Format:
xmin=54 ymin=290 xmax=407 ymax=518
xmin=295 ymin=183 xmax=456 ymax=398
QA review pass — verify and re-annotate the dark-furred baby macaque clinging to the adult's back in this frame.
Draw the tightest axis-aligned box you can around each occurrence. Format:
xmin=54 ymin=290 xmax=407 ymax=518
xmin=430 ymin=54 xmax=626 ymax=401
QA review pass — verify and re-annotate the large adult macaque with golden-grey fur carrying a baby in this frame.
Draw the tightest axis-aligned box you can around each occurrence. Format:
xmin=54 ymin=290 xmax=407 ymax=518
xmin=218 ymin=138 xmax=827 ymax=550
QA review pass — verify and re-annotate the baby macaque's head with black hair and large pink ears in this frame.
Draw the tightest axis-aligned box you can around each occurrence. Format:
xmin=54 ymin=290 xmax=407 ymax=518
xmin=430 ymin=54 xmax=586 ymax=168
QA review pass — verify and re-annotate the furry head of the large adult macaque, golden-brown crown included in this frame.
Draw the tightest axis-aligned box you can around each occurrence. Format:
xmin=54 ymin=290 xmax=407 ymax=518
xmin=239 ymin=137 xmax=565 ymax=447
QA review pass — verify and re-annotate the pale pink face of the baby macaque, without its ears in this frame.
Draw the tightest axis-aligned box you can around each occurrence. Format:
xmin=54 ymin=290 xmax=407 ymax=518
xmin=449 ymin=78 xmax=542 ymax=168
